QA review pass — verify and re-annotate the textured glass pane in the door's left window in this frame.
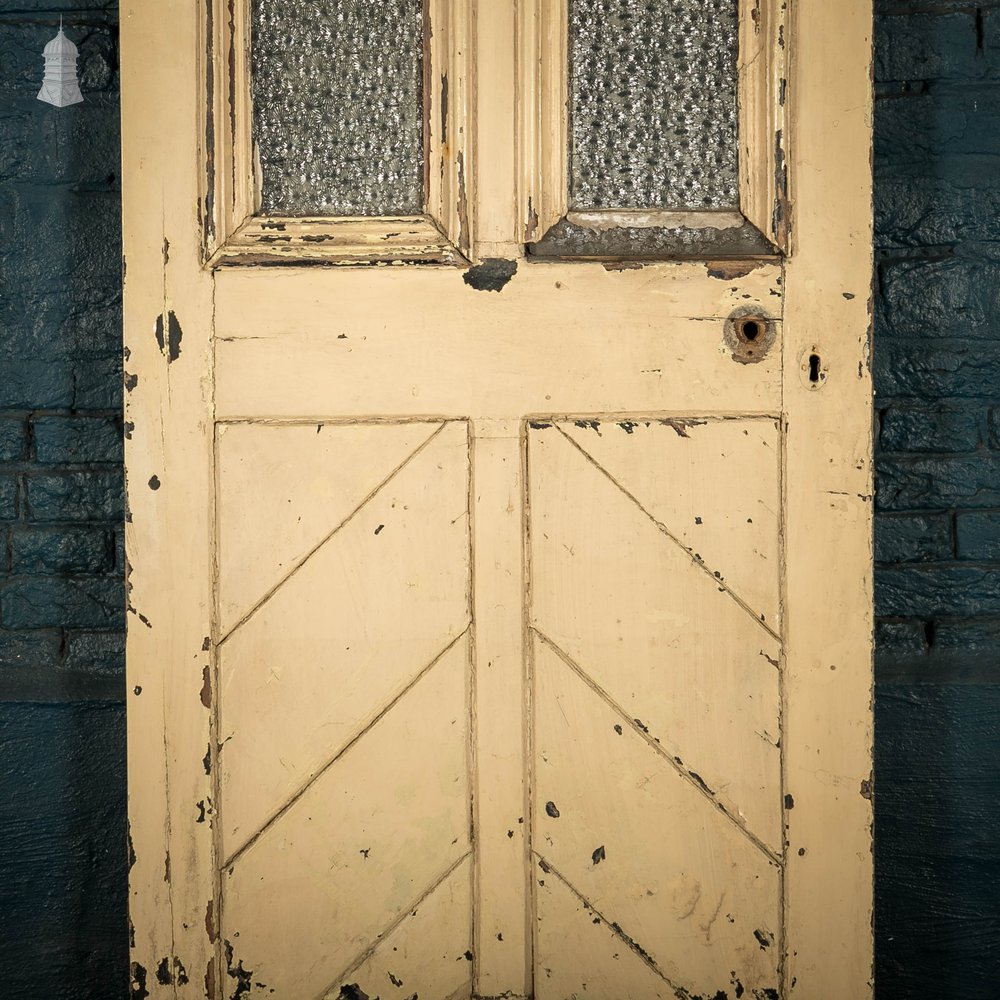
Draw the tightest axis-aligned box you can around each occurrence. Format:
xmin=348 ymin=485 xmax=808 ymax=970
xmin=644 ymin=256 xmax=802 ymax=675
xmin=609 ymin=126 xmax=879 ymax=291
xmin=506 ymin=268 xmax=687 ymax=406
xmin=251 ymin=0 xmax=424 ymax=215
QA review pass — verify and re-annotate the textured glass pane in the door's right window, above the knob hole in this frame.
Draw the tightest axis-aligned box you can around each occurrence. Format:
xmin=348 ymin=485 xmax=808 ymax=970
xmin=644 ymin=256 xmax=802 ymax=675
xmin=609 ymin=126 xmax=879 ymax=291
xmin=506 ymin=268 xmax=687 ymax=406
xmin=570 ymin=0 xmax=739 ymax=209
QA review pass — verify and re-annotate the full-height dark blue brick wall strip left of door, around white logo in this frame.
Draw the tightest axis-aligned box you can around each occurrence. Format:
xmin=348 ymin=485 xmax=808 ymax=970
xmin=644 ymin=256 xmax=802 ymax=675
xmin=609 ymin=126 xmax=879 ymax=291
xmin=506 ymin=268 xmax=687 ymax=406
xmin=0 ymin=0 xmax=127 ymax=1000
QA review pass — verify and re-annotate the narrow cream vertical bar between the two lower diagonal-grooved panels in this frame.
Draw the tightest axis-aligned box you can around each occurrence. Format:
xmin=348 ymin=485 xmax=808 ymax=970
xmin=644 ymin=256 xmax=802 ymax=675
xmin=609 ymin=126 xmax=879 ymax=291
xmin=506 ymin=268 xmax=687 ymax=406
xmin=470 ymin=419 xmax=532 ymax=998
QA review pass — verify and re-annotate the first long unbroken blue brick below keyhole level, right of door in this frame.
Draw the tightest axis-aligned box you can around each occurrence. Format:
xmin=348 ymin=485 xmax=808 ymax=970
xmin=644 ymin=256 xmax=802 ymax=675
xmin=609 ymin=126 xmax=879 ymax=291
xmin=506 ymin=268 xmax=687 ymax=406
xmin=875 ymin=453 xmax=1000 ymax=511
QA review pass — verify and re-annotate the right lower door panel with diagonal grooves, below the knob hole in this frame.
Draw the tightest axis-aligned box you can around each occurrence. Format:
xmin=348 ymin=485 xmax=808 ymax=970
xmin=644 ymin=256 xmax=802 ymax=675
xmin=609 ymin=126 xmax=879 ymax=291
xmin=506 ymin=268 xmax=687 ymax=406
xmin=527 ymin=418 xmax=783 ymax=1000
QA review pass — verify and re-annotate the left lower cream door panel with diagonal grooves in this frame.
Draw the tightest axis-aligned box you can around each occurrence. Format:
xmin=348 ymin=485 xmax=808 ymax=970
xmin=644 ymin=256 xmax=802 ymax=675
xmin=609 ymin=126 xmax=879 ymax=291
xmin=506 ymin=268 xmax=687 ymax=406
xmin=215 ymin=421 xmax=472 ymax=1000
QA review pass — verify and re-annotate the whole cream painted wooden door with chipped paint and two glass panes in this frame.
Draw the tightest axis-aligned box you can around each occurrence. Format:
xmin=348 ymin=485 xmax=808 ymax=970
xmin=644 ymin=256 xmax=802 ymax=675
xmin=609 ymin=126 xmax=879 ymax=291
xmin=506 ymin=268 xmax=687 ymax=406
xmin=122 ymin=0 xmax=872 ymax=1000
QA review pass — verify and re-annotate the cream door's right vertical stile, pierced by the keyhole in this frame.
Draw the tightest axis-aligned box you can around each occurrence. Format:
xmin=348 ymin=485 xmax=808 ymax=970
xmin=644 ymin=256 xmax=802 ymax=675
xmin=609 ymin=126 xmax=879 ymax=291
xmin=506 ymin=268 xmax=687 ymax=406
xmin=783 ymin=0 xmax=872 ymax=1000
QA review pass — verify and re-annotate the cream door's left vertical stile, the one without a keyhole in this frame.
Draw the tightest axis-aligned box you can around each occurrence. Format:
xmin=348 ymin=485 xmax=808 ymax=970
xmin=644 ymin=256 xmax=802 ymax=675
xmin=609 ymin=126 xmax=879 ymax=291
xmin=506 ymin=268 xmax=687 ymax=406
xmin=121 ymin=0 xmax=215 ymax=998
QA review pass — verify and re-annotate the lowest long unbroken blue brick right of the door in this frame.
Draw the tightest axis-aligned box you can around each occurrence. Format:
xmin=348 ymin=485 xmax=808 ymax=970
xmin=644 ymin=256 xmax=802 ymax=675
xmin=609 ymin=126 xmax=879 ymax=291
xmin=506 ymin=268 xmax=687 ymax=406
xmin=875 ymin=563 xmax=1000 ymax=618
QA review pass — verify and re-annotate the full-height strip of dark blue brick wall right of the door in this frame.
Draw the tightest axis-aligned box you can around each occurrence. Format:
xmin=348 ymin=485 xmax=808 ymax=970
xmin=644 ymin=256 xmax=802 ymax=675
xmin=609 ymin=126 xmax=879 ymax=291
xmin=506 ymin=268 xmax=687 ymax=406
xmin=875 ymin=0 xmax=1000 ymax=1000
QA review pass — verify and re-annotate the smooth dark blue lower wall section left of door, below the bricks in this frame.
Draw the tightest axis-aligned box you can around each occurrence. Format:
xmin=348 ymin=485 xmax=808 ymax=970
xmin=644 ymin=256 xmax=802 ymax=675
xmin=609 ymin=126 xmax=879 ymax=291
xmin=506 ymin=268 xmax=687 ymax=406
xmin=0 ymin=704 xmax=127 ymax=1000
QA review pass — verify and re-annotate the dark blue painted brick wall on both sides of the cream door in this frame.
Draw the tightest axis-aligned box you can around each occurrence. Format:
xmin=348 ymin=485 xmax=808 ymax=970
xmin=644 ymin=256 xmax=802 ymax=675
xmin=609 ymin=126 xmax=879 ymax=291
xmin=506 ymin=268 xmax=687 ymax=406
xmin=0 ymin=0 xmax=1000 ymax=1000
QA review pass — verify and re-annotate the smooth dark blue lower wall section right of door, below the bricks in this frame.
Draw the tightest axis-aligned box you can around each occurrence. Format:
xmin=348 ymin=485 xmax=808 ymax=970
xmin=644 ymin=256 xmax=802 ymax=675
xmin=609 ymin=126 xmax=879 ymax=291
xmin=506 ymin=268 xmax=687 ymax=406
xmin=875 ymin=684 xmax=1000 ymax=1000
